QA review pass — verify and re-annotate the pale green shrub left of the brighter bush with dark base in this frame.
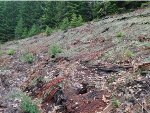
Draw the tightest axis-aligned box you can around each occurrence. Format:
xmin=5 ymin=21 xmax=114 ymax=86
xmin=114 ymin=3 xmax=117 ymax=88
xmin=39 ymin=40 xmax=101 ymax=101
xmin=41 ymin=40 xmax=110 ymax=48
xmin=21 ymin=52 xmax=34 ymax=63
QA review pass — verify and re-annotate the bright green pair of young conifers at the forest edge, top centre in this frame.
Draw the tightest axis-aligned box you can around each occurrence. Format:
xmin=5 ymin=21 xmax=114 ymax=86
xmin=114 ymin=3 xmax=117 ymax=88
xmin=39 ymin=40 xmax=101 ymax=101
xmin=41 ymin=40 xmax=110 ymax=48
xmin=70 ymin=13 xmax=83 ymax=27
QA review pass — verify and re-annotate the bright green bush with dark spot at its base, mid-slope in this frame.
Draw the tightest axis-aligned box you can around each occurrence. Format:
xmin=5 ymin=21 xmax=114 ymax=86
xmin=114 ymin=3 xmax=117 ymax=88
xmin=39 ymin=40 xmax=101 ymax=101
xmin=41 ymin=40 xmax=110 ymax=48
xmin=48 ymin=44 xmax=62 ymax=58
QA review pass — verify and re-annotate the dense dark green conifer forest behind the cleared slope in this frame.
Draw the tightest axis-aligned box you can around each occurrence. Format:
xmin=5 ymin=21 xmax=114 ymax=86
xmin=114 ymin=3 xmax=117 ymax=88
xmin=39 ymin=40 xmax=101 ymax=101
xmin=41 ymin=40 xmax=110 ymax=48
xmin=0 ymin=1 xmax=149 ymax=42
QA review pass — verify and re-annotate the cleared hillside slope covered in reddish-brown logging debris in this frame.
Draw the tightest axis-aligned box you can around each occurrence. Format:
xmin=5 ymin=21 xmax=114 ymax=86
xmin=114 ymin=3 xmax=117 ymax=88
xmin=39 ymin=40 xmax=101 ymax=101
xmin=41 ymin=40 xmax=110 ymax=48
xmin=0 ymin=8 xmax=150 ymax=113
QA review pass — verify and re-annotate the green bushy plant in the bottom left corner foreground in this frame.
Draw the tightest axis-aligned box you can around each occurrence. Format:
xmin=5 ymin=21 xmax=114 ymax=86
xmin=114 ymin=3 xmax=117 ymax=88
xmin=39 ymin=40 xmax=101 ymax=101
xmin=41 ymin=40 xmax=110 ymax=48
xmin=10 ymin=91 xmax=40 ymax=113
